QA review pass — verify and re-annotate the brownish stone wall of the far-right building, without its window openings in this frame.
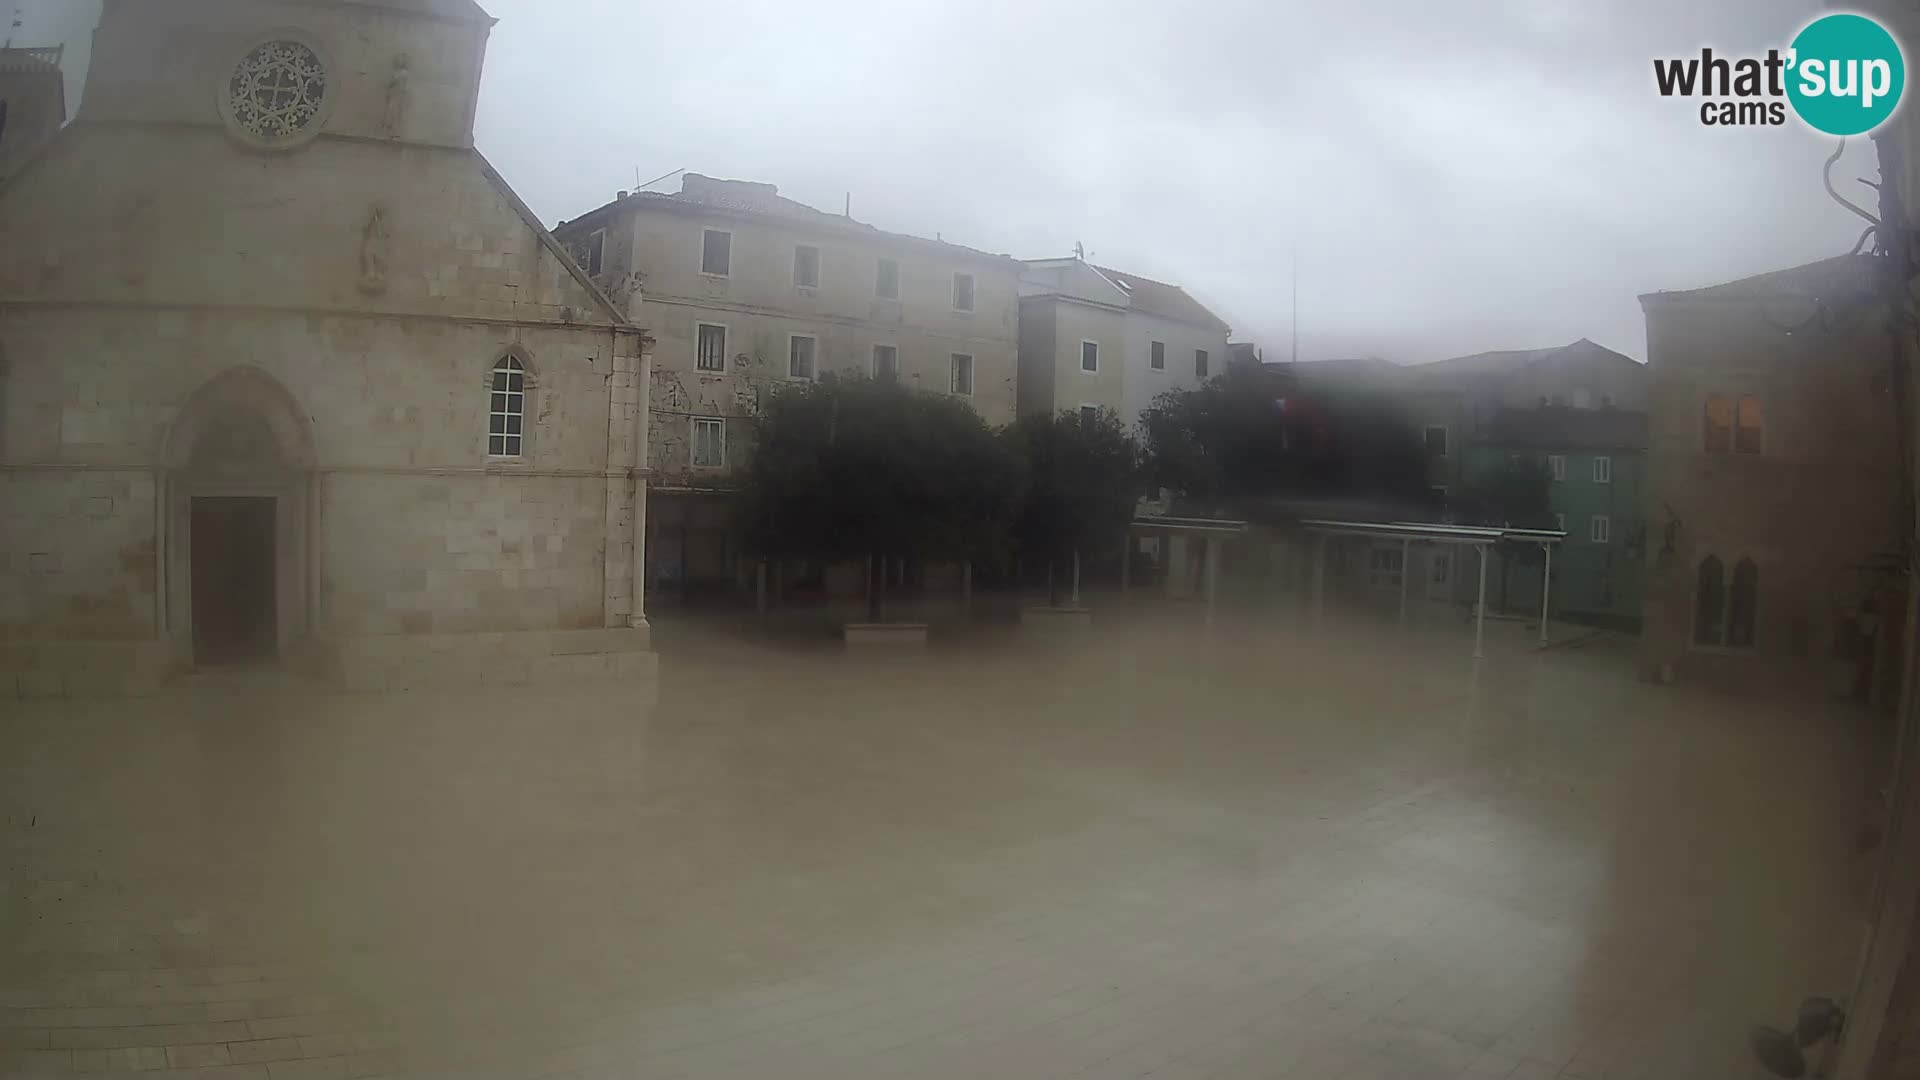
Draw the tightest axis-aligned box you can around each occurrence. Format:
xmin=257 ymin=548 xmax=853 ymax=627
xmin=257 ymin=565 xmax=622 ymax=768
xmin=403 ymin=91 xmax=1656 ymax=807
xmin=1642 ymin=300 xmax=1903 ymax=686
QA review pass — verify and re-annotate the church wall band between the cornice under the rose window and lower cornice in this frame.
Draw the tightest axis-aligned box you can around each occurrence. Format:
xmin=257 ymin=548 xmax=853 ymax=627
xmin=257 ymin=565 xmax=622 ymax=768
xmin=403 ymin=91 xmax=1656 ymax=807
xmin=0 ymin=125 xmax=622 ymax=325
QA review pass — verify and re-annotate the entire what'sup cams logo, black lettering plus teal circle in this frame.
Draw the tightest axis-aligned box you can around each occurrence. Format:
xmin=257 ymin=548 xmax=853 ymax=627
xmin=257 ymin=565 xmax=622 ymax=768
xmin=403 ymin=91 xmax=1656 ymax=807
xmin=1653 ymin=13 xmax=1907 ymax=135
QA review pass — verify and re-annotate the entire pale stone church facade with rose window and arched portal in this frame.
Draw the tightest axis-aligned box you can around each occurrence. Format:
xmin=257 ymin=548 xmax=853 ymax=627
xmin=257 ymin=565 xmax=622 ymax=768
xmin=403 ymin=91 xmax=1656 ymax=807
xmin=0 ymin=0 xmax=655 ymax=698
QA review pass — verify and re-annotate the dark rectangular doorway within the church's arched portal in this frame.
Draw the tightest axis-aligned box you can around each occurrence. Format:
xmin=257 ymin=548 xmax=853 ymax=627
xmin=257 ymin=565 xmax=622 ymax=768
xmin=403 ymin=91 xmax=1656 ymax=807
xmin=188 ymin=496 xmax=278 ymax=665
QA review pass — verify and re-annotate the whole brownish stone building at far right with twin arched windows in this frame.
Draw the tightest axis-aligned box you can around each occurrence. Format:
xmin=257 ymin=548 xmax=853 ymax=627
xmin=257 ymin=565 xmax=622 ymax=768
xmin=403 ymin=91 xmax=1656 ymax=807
xmin=1642 ymin=256 xmax=1907 ymax=698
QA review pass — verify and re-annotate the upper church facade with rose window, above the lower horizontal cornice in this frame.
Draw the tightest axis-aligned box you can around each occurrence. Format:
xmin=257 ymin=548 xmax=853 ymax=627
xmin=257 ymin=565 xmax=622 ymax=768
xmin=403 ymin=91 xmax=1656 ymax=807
xmin=0 ymin=0 xmax=624 ymax=325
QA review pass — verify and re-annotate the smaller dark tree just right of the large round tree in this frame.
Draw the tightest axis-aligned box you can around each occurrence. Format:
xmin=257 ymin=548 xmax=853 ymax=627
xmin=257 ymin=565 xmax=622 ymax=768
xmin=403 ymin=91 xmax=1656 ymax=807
xmin=1006 ymin=409 xmax=1140 ymax=603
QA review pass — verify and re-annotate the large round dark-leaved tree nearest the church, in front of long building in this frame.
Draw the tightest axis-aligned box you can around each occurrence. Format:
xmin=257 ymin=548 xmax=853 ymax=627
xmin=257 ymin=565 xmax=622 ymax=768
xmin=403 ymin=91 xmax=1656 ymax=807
xmin=745 ymin=373 xmax=1018 ymax=619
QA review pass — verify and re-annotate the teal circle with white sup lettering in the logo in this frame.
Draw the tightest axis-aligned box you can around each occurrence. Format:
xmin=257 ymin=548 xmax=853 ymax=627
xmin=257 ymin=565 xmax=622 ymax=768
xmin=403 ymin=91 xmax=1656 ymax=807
xmin=1788 ymin=13 xmax=1907 ymax=135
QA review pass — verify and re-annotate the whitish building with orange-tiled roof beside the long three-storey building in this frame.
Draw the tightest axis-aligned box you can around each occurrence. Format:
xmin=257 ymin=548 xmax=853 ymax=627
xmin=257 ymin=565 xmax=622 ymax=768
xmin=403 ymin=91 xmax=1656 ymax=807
xmin=1020 ymin=258 xmax=1231 ymax=425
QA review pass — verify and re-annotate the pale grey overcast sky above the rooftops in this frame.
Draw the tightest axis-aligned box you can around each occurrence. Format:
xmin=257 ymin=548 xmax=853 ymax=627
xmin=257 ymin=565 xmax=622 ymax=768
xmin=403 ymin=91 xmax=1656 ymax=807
xmin=11 ymin=0 xmax=1874 ymax=361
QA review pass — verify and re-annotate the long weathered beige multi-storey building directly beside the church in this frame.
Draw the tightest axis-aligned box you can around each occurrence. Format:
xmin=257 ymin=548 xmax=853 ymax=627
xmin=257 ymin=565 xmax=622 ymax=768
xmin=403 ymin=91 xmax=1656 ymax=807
xmin=555 ymin=173 xmax=1020 ymax=592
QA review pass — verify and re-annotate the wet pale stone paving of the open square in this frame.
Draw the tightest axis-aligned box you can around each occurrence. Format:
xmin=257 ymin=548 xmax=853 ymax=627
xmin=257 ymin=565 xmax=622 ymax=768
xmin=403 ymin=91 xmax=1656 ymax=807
xmin=0 ymin=625 xmax=1868 ymax=1080
